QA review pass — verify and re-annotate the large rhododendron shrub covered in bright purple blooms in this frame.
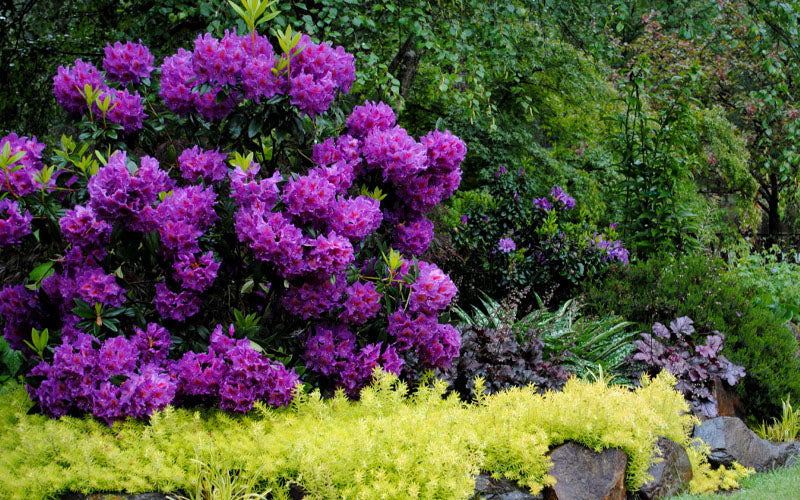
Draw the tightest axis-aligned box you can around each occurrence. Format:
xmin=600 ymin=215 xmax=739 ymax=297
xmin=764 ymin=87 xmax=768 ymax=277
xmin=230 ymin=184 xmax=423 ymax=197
xmin=0 ymin=12 xmax=466 ymax=424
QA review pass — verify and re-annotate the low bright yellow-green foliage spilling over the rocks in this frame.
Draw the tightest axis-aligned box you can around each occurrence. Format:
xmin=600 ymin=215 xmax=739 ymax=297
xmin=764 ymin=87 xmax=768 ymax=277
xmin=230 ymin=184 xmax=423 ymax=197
xmin=0 ymin=373 xmax=752 ymax=499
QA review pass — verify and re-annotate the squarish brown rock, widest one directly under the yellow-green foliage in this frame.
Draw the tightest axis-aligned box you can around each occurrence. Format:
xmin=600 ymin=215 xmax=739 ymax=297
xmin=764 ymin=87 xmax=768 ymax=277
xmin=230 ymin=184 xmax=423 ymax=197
xmin=544 ymin=443 xmax=628 ymax=500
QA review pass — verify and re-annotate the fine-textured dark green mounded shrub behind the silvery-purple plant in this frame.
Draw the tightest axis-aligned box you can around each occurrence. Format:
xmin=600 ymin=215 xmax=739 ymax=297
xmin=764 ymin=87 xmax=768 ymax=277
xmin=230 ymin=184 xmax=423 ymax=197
xmin=585 ymin=255 xmax=800 ymax=420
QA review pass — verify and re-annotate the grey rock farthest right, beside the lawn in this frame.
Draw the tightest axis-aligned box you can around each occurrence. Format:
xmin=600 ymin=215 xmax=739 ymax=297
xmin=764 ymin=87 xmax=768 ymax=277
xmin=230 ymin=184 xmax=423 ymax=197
xmin=694 ymin=417 xmax=800 ymax=472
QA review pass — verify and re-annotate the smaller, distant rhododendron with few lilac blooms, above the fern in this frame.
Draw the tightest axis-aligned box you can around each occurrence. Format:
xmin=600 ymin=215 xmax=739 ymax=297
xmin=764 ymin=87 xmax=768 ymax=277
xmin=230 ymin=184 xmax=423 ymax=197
xmin=447 ymin=166 xmax=628 ymax=305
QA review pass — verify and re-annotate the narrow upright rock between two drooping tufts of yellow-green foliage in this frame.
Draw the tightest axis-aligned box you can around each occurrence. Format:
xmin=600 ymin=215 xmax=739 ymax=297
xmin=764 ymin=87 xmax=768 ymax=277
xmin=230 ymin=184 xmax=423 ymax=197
xmin=636 ymin=437 xmax=692 ymax=500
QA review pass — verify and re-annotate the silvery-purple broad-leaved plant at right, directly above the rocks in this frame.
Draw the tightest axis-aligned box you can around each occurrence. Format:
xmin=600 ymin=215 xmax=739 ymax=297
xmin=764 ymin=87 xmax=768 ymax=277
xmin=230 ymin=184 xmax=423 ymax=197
xmin=633 ymin=316 xmax=745 ymax=418
